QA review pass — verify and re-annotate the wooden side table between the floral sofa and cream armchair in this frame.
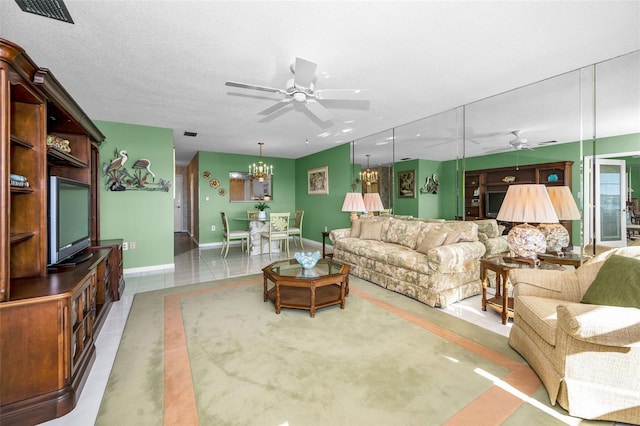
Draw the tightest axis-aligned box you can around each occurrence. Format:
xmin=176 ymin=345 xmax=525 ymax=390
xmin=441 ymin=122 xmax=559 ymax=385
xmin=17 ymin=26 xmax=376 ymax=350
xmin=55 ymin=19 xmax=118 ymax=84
xmin=480 ymin=256 xmax=565 ymax=324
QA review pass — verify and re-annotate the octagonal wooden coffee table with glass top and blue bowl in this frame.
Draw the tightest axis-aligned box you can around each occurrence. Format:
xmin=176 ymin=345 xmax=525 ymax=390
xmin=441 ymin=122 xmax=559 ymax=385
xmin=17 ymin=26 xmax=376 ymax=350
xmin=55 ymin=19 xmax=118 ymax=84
xmin=262 ymin=259 xmax=349 ymax=318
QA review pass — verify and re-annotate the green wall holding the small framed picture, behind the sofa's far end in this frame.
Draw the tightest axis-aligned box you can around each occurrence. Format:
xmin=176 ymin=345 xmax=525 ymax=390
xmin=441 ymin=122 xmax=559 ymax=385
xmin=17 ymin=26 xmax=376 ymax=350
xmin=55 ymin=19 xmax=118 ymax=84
xmin=295 ymin=143 xmax=360 ymax=236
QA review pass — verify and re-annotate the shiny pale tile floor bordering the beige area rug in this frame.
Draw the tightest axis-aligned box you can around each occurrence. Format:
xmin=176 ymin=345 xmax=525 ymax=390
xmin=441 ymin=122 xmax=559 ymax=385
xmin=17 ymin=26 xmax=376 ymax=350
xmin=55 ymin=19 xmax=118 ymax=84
xmin=43 ymin=234 xmax=511 ymax=426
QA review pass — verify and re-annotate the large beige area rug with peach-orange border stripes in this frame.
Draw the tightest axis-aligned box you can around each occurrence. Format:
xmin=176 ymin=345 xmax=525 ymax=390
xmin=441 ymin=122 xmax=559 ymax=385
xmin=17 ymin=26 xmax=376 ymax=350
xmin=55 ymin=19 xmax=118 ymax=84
xmin=96 ymin=275 xmax=602 ymax=426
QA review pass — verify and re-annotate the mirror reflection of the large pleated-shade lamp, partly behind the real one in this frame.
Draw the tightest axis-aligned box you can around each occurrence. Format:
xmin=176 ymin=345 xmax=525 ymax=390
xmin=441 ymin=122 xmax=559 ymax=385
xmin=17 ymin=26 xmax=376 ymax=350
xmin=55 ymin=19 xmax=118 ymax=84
xmin=539 ymin=186 xmax=580 ymax=255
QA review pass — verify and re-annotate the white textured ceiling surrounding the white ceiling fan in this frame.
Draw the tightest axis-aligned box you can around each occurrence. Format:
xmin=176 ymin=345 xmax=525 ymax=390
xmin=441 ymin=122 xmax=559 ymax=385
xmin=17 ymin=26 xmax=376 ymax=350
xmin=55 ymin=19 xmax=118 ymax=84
xmin=0 ymin=0 xmax=640 ymax=164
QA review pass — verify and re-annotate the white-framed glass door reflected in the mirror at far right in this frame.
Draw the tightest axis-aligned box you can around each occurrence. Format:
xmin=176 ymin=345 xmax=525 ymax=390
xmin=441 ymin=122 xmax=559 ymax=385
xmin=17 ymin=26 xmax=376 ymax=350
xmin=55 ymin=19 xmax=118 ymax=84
xmin=594 ymin=158 xmax=627 ymax=247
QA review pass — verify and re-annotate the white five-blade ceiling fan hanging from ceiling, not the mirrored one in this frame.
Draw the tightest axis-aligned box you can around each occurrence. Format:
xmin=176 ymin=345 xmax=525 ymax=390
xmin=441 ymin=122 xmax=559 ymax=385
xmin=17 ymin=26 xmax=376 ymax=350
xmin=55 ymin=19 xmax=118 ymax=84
xmin=225 ymin=58 xmax=364 ymax=121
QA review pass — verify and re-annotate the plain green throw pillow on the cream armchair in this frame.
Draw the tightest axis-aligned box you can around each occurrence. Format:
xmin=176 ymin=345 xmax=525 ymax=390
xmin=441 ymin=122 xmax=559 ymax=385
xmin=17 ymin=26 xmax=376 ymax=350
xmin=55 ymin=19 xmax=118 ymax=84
xmin=581 ymin=254 xmax=640 ymax=309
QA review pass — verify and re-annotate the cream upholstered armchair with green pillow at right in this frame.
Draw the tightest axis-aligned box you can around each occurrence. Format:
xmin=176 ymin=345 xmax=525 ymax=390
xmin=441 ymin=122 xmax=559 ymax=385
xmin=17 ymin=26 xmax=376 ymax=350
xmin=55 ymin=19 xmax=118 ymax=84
xmin=509 ymin=247 xmax=640 ymax=424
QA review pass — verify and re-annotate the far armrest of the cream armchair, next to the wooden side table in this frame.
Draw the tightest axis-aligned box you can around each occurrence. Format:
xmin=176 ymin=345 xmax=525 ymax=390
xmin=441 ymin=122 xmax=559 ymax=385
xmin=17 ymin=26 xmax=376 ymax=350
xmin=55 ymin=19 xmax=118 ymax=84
xmin=509 ymin=269 xmax=582 ymax=302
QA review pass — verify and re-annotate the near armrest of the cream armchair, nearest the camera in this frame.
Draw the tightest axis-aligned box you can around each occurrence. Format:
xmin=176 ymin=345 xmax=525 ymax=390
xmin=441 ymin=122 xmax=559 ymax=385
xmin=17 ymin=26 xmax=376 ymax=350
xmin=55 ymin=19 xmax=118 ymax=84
xmin=557 ymin=303 xmax=640 ymax=347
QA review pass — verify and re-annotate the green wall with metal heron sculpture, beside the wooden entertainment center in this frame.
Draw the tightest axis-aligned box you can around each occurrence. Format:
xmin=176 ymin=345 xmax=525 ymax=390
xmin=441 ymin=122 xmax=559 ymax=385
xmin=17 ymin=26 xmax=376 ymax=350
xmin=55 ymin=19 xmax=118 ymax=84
xmin=94 ymin=121 xmax=174 ymax=269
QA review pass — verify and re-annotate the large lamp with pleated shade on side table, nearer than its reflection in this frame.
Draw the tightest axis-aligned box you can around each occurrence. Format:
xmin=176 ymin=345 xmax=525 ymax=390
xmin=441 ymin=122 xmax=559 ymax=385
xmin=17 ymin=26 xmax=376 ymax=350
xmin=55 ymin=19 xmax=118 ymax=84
xmin=496 ymin=184 xmax=558 ymax=261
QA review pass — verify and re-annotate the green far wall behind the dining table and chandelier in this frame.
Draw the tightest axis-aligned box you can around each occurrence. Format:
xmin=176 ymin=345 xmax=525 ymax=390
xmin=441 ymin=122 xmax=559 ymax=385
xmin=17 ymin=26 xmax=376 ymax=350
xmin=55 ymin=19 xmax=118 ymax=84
xmin=194 ymin=151 xmax=296 ymax=245
